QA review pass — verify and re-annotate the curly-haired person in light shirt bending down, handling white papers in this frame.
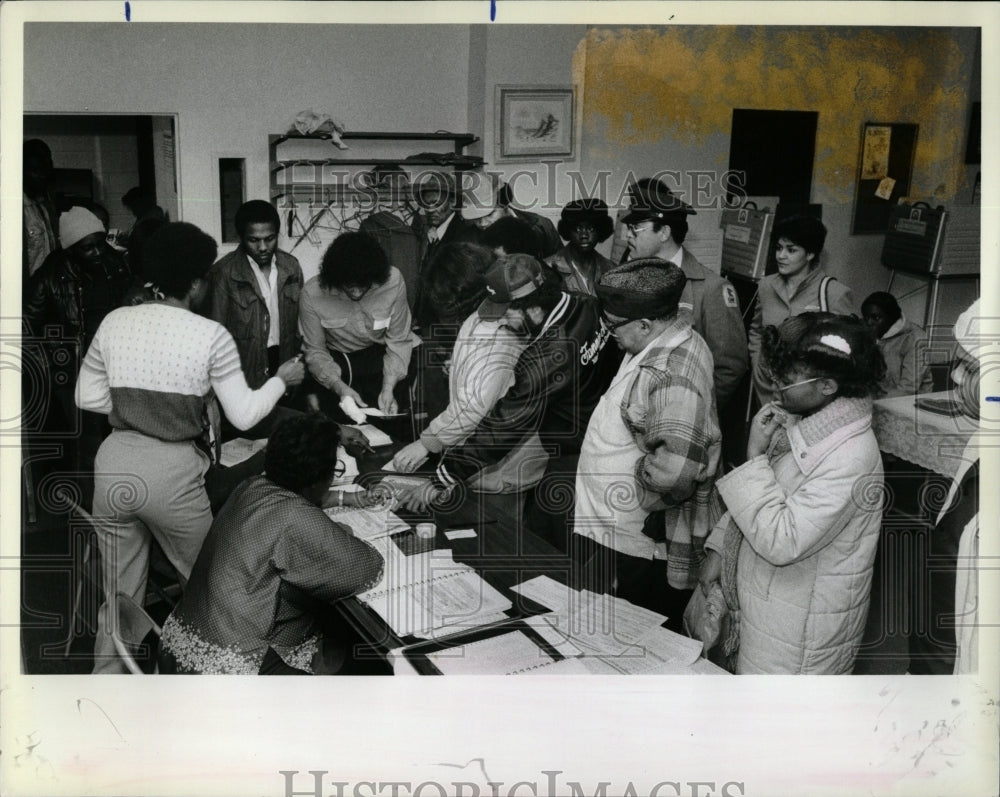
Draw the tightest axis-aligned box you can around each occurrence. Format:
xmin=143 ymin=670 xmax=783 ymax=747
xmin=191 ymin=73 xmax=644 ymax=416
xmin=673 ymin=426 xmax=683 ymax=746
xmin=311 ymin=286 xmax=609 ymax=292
xmin=299 ymin=232 xmax=420 ymax=420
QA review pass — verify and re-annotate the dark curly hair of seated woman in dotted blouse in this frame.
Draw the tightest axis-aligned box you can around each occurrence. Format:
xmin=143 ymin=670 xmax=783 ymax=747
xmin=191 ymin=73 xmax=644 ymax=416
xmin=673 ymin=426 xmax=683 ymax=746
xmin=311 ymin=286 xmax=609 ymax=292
xmin=264 ymin=412 xmax=340 ymax=493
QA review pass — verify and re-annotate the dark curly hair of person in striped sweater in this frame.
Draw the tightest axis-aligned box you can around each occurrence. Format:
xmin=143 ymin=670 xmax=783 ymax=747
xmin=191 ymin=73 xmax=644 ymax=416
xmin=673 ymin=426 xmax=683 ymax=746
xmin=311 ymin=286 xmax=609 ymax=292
xmin=142 ymin=221 xmax=219 ymax=299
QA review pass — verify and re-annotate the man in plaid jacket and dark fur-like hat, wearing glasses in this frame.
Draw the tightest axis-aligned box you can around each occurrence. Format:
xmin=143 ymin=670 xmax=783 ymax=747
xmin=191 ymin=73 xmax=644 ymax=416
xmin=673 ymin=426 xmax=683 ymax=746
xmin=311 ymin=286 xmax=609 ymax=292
xmin=573 ymin=258 xmax=722 ymax=631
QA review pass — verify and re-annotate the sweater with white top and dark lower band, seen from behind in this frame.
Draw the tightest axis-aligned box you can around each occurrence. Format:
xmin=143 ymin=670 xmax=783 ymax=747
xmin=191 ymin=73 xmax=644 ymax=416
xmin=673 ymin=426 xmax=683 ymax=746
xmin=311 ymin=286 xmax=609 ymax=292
xmin=76 ymin=302 xmax=285 ymax=442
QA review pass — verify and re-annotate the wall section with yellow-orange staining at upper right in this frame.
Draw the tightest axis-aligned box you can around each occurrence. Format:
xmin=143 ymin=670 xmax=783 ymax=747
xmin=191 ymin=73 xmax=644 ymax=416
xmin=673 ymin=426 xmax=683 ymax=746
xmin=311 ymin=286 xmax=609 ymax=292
xmin=574 ymin=26 xmax=979 ymax=330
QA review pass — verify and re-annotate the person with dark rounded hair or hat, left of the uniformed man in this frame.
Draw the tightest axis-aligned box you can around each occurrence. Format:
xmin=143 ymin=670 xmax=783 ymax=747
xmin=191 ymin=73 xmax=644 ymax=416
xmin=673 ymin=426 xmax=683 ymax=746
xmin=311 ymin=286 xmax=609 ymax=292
xmin=546 ymin=199 xmax=615 ymax=296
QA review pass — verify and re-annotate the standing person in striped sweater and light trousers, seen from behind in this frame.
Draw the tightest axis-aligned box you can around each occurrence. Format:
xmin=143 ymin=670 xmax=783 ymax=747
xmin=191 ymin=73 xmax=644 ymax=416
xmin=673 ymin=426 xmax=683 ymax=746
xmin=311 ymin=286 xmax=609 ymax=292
xmin=76 ymin=222 xmax=305 ymax=672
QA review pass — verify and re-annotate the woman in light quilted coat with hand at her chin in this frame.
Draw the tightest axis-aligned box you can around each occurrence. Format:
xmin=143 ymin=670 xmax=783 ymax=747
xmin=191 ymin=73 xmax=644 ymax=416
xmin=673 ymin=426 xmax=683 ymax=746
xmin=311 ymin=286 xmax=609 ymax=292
xmin=700 ymin=317 xmax=885 ymax=674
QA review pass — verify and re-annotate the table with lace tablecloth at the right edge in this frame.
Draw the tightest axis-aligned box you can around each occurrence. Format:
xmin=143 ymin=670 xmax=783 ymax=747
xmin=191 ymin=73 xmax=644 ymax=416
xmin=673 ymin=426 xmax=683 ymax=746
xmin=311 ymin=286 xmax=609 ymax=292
xmin=872 ymin=391 xmax=979 ymax=478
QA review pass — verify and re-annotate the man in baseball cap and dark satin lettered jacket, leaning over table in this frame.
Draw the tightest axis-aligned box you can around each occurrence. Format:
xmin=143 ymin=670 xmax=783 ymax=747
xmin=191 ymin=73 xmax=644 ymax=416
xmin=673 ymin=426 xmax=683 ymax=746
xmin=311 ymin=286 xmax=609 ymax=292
xmin=396 ymin=254 xmax=619 ymax=508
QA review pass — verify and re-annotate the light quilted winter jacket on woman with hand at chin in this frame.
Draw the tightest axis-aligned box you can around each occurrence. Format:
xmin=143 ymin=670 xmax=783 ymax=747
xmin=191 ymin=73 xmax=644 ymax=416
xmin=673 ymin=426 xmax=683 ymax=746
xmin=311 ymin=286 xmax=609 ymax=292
xmin=710 ymin=399 xmax=883 ymax=674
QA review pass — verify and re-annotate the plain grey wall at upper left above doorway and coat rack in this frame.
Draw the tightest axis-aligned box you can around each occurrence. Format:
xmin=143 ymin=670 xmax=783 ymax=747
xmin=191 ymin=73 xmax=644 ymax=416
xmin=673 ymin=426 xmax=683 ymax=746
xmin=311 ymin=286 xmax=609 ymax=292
xmin=24 ymin=23 xmax=469 ymax=276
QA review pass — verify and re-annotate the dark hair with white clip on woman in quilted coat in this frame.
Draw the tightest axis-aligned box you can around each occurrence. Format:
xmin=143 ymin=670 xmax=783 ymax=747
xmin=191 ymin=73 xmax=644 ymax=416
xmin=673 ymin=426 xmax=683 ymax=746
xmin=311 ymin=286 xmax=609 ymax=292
xmin=762 ymin=313 xmax=885 ymax=398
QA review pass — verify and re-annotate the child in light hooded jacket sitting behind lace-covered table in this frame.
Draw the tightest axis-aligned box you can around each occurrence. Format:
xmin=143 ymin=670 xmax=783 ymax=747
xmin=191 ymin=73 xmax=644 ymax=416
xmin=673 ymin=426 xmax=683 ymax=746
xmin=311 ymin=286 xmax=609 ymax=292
xmin=861 ymin=291 xmax=934 ymax=398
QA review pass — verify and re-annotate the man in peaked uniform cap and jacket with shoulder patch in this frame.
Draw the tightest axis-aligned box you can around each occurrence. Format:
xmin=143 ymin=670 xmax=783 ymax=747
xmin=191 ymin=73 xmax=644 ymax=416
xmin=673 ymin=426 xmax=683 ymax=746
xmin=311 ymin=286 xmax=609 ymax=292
xmin=622 ymin=179 xmax=750 ymax=408
